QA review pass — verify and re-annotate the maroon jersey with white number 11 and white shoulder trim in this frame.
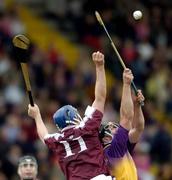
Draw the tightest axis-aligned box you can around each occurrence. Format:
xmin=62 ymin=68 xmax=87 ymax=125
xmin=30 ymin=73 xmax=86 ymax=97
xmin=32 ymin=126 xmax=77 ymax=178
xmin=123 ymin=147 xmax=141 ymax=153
xmin=45 ymin=106 xmax=109 ymax=180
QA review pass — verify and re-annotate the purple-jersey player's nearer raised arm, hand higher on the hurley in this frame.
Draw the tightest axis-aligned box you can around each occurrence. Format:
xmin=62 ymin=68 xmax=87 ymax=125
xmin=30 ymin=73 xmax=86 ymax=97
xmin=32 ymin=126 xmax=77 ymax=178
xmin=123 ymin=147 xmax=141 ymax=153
xmin=120 ymin=68 xmax=134 ymax=130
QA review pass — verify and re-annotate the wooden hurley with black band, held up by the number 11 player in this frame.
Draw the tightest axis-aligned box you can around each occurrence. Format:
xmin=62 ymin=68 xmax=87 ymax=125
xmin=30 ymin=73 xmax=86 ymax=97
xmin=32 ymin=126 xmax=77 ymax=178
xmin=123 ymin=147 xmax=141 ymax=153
xmin=13 ymin=35 xmax=34 ymax=106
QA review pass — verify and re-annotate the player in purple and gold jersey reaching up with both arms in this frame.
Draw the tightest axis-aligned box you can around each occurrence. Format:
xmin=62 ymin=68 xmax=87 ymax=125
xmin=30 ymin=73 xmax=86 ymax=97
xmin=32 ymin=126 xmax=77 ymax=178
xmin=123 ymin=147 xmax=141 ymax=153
xmin=100 ymin=69 xmax=144 ymax=180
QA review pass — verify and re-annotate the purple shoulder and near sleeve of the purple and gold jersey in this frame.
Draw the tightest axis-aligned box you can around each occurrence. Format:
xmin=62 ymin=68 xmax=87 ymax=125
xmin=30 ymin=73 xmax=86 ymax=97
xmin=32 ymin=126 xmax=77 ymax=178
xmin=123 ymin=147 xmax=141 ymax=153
xmin=105 ymin=126 xmax=129 ymax=158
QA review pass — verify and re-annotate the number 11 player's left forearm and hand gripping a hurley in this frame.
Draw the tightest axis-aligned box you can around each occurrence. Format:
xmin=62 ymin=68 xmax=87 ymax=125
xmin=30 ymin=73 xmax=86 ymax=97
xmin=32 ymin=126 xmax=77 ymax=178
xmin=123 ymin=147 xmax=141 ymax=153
xmin=28 ymin=104 xmax=48 ymax=143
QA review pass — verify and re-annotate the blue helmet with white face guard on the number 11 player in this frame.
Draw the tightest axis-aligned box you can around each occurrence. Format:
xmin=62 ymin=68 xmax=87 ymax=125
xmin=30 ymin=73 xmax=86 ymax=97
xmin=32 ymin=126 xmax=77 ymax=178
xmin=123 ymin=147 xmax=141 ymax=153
xmin=53 ymin=105 xmax=82 ymax=130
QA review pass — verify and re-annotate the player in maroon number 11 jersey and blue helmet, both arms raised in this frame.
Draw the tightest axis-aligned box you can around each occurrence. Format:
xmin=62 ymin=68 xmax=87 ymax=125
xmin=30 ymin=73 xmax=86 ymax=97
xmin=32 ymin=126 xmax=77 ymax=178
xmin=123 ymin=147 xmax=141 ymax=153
xmin=28 ymin=52 xmax=113 ymax=180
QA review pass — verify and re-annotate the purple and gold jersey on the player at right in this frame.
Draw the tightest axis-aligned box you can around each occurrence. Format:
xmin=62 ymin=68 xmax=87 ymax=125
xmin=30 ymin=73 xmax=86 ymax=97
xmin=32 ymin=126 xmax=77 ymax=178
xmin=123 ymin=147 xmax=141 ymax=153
xmin=105 ymin=126 xmax=138 ymax=180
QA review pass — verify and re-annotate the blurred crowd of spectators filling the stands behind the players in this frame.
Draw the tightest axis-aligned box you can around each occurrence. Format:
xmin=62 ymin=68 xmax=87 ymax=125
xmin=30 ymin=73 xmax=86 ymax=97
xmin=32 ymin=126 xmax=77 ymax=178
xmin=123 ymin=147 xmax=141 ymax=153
xmin=0 ymin=0 xmax=172 ymax=180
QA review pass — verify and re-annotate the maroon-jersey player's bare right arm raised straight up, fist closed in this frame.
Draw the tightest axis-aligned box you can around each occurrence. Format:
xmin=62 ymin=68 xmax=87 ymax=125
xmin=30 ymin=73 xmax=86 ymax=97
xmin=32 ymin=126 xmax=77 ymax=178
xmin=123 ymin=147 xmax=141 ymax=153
xmin=92 ymin=51 xmax=106 ymax=113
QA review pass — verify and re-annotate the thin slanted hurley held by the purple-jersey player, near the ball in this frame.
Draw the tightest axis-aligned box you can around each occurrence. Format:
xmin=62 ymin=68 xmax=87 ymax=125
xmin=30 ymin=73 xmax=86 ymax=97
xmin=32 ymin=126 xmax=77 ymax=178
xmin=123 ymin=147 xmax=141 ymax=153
xmin=95 ymin=11 xmax=144 ymax=106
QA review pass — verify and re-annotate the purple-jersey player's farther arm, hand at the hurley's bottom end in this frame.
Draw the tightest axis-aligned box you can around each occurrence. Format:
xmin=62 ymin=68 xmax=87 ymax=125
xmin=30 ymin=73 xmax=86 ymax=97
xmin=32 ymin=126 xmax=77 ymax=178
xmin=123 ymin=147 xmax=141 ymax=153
xmin=129 ymin=90 xmax=145 ymax=143
